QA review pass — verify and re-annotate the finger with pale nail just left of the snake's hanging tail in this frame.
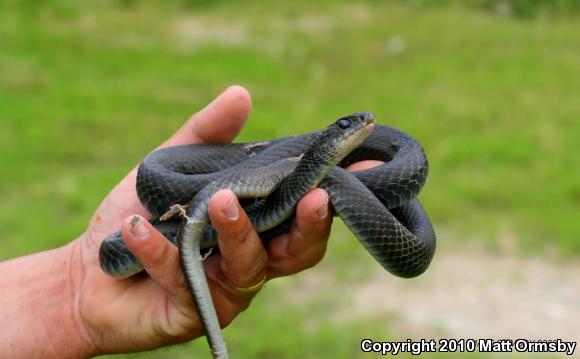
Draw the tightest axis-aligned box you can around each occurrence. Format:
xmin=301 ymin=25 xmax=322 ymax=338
xmin=121 ymin=216 xmax=192 ymax=302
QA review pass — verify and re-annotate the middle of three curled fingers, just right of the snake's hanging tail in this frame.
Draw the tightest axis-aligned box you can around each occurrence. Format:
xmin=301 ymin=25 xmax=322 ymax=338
xmin=209 ymin=190 xmax=267 ymax=296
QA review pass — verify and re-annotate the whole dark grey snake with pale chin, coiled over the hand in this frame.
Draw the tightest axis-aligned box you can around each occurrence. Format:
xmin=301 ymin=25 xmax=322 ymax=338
xmin=99 ymin=112 xmax=435 ymax=358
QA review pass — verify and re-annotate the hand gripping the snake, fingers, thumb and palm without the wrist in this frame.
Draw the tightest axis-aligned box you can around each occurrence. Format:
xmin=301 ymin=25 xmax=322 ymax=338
xmin=69 ymin=86 xmax=332 ymax=354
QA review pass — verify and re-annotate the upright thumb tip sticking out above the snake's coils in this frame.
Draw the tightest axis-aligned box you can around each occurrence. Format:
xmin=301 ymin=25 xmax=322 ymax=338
xmin=161 ymin=86 xmax=252 ymax=147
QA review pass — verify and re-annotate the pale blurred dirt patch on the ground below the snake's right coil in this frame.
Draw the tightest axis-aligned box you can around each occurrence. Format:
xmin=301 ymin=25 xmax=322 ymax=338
xmin=348 ymin=248 xmax=580 ymax=340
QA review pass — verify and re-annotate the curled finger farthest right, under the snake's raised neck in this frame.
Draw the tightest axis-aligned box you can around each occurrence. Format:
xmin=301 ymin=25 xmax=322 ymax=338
xmin=268 ymin=188 xmax=332 ymax=277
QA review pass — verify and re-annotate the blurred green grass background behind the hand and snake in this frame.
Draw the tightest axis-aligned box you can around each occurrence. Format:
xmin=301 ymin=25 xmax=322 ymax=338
xmin=0 ymin=0 xmax=580 ymax=358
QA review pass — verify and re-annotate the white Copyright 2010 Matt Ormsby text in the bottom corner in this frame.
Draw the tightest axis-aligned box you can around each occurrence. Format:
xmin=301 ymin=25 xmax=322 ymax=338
xmin=360 ymin=339 xmax=577 ymax=355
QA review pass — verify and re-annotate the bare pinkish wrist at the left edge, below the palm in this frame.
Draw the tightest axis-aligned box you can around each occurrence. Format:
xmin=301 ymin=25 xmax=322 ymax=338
xmin=0 ymin=241 xmax=93 ymax=358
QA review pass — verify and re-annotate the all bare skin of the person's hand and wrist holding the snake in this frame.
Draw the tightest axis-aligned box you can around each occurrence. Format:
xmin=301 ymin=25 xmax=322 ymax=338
xmin=0 ymin=86 xmax=332 ymax=358
